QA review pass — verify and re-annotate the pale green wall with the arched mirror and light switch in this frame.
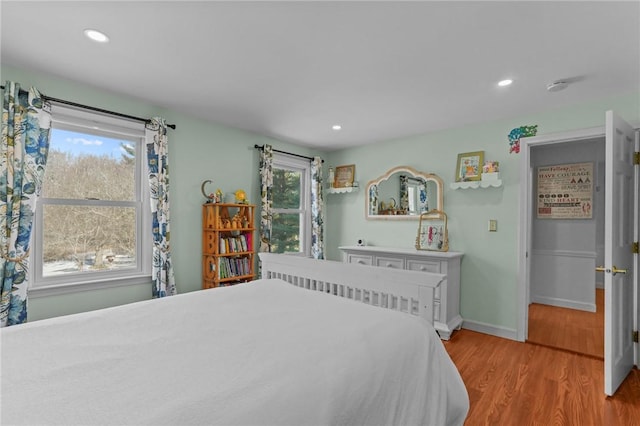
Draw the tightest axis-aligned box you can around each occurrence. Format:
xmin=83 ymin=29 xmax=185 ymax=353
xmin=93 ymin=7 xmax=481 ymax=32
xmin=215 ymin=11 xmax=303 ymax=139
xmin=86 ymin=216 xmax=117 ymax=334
xmin=325 ymin=93 xmax=640 ymax=338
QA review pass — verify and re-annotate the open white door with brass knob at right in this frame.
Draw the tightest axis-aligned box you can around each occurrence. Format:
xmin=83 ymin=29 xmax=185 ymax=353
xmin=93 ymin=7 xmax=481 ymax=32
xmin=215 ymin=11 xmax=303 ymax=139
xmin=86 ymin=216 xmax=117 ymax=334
xmin=603 ymin=111 xmax=636 ymax=395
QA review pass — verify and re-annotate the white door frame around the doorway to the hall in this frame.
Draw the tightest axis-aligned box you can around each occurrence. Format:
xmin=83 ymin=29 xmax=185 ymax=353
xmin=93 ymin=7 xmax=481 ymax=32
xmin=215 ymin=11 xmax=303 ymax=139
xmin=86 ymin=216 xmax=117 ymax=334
xmin=517 ymin=126 xmax=605 ymax=342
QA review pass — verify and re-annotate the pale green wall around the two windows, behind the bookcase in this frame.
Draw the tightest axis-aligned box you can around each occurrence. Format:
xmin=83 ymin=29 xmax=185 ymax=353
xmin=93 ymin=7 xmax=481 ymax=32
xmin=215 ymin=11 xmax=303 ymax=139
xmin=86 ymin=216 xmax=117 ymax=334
xmin=0 ymin=65 xmax=317 ymax=321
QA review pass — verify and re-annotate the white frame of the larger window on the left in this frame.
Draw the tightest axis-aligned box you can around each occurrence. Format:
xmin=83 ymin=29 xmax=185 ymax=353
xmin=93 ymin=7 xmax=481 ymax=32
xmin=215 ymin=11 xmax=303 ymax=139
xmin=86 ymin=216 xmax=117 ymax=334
xmin=29 ymin=104 xmax=152 ymax=297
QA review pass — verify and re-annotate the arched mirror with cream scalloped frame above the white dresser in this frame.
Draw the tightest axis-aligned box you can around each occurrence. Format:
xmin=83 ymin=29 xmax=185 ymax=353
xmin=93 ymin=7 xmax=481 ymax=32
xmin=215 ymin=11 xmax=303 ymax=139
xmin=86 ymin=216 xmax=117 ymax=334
xmin=365 ymin=166 xmax=444 ymax=220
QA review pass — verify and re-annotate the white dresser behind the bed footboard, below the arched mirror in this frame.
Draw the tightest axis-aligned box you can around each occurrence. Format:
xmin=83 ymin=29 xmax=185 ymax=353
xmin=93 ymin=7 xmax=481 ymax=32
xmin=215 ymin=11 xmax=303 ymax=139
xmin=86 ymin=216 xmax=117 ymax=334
xmin=340 ymin=246 xmax=463 ymax=340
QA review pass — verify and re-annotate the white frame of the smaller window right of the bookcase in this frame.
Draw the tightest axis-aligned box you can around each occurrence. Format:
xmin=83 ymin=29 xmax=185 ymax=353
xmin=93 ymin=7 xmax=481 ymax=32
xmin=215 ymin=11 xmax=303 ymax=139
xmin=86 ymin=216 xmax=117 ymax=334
xmin=272 ymin=152 xmax=311 ymax=257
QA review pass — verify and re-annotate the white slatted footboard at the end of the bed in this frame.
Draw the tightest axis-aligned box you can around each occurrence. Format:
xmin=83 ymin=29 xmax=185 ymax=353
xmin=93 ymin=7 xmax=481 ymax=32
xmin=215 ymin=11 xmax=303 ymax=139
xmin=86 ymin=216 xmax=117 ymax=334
xmin=259 ymin=253 xmax=446 ymax=324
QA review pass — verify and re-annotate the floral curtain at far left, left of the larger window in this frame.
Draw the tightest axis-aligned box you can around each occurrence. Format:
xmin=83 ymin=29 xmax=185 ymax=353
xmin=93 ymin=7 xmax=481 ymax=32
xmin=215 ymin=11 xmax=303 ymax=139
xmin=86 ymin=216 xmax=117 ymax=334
xmin=0 ymin=81 xmax=51 ymax=327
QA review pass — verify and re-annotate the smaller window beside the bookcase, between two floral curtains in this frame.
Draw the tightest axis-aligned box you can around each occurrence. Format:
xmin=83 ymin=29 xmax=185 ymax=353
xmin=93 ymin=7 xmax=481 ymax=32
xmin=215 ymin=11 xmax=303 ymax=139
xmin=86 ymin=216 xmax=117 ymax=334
xmin=271 ymin=153 xmax=311 ymax=256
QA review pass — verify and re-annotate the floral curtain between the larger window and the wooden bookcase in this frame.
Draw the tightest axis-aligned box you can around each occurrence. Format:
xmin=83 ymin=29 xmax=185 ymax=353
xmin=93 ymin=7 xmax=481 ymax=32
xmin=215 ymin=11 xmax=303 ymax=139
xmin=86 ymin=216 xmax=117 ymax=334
xmin=146 ymin=117 xmax=178 ymax=298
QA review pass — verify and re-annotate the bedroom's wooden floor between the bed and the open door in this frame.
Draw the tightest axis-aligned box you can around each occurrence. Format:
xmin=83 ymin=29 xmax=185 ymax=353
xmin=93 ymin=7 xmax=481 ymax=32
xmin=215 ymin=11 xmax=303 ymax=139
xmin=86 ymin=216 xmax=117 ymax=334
xmin=444 ymin=329 xmax=640 ymax=426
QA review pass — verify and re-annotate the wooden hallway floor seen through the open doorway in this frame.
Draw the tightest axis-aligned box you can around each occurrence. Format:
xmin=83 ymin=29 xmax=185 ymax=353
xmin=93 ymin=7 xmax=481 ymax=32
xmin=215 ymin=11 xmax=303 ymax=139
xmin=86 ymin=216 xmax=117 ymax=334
xmin=527 ymin=289 xmax=604 ymax=359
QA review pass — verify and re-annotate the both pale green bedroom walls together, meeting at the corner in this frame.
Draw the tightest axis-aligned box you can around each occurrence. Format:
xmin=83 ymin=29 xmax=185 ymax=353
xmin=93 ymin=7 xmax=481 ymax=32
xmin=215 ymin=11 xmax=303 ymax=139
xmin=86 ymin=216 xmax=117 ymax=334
xmin=0 ymin=65 xmax=640 ymax=337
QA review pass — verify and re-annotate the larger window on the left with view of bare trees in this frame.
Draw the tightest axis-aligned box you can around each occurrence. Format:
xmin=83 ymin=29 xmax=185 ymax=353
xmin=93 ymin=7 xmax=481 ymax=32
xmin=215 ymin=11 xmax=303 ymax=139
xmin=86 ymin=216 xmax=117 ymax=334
xmin=30 ymin=105 xmax=151 ymax=295
